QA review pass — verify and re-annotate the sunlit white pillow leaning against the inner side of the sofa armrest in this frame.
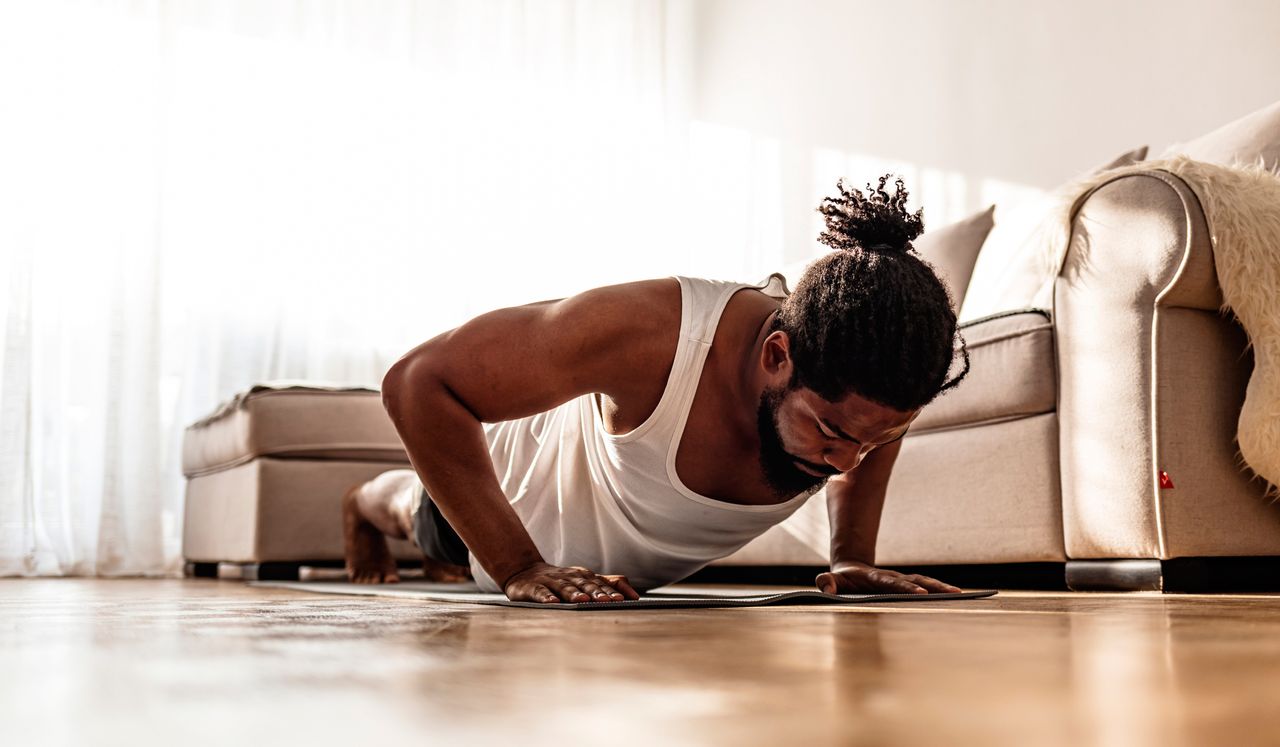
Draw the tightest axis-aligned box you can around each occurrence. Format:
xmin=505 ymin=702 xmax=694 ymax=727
xmin=960 ymin=146 xmax=1147 ymax=321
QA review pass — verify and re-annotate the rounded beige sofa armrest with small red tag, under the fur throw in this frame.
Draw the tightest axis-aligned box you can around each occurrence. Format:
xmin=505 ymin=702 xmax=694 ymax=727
xmin=1053 ymin=170 xmax=1251 ymax=559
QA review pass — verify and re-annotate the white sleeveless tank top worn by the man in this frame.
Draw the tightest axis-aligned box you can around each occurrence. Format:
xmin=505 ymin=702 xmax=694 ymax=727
xmin=471 ymin=275 xmax=812 ymax=591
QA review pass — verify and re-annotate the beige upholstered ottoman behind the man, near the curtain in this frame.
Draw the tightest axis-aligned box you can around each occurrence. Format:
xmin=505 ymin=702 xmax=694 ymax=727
xmin=182 ymin=381 xmax=421 ymax=578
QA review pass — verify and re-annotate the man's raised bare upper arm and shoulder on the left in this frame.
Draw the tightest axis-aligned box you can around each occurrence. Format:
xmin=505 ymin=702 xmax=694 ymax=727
xmin=383 ymin=279 xmax=680 ymax=422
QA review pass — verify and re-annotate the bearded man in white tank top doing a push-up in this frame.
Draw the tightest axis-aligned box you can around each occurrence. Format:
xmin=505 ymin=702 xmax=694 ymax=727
xmin=343 ymin=177 xmax=968 ymax=602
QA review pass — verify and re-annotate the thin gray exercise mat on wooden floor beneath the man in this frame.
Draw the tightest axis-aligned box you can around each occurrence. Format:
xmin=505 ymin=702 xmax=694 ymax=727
xmin=250 ymin=581 xmax=996 ymax=610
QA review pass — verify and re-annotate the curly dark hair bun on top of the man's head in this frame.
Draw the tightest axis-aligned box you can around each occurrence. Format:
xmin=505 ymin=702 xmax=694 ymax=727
xmin=818 ymin=174 xmax=924 ymax=255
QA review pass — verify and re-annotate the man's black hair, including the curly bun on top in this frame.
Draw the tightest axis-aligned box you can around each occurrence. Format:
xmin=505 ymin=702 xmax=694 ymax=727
xmin=772 ymin=174 xmax=969 ymax=412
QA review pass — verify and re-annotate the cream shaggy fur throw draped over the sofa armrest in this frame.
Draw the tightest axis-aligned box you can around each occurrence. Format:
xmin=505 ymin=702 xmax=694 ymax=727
xmin=1039 ymin=156 xmax=1280 ymax=498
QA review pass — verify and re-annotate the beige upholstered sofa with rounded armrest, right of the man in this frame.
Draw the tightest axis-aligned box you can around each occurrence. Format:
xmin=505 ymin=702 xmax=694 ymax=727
xmin=722 ymin=171 xmax=1280 ymax=588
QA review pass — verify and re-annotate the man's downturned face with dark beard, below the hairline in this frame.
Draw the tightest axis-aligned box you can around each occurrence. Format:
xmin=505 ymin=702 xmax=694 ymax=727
xmin=755 ymin=378 xmax=919 ymax=495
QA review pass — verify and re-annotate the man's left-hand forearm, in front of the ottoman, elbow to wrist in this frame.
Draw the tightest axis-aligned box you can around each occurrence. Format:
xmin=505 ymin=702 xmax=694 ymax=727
xmin=383 ymin=370 xmax=543 ymax=587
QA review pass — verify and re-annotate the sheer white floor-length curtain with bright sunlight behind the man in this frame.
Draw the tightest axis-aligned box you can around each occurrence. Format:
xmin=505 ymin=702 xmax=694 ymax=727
xmin=0 ymin=0 xmax=782 ymax=576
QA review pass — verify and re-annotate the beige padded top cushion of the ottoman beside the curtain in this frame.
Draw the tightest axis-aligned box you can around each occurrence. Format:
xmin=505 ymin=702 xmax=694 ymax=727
xmin=182 ymin=381 xmax=408 ymax=477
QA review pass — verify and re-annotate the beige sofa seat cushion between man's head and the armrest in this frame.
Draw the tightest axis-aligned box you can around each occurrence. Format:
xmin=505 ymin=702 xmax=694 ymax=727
xmin=911 ymin=310 xmax=1057 ymax=435
